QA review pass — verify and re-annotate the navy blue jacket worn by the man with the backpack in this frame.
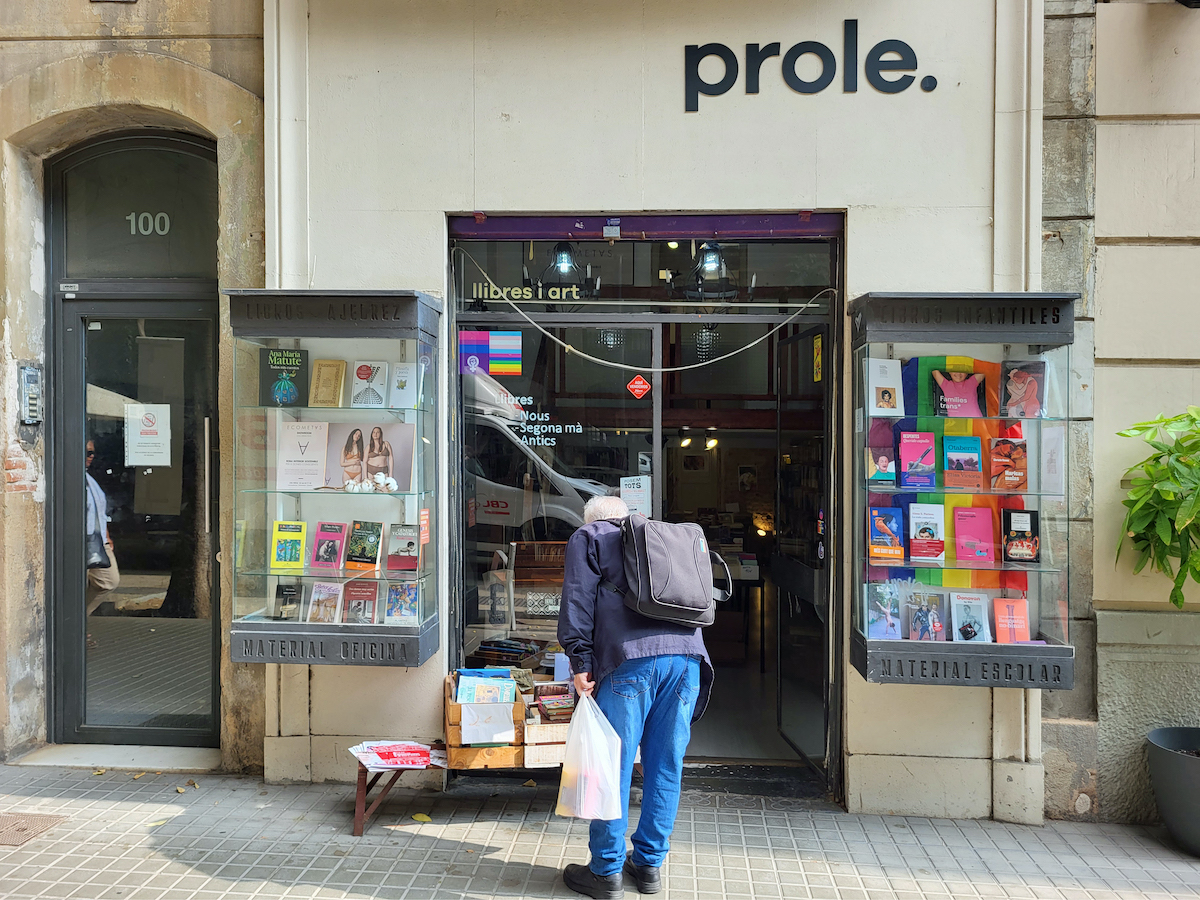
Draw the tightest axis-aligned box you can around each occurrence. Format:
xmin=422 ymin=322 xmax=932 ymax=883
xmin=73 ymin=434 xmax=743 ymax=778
xmin=558 ymin=520 xmax=713 ymax=721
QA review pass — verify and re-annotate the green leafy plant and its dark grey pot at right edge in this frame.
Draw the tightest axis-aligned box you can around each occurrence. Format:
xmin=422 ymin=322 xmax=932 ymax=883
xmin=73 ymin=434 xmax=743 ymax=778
xmin=1117 ymin=407 xmax=1200 ymax=856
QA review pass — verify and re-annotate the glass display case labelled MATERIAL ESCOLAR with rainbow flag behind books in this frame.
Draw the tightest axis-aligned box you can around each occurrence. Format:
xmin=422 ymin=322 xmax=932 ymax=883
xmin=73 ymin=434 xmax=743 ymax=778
xmin=846 ymin=294 xmax=1075 ymax=690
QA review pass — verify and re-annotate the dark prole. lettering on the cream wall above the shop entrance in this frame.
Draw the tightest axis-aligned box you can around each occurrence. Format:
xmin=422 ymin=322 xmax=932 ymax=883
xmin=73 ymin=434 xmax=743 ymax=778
xmin=684 ymin=19 xmax=937 ymax=113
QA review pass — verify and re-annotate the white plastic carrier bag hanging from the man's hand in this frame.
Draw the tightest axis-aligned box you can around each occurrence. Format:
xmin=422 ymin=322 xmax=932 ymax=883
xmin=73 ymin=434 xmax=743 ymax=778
xmin=554 ymin=694 xmax=620 ymax=820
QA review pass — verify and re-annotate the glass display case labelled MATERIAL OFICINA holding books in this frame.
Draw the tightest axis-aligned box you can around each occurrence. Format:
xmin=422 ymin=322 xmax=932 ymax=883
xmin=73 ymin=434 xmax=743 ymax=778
xmin=228 ymin=290 xmax=442 ymax=666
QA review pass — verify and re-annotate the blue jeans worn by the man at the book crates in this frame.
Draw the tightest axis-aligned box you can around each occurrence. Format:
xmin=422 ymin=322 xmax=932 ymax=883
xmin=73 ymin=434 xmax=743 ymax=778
xmin=588 ymin=656 xmax=700 ymax=876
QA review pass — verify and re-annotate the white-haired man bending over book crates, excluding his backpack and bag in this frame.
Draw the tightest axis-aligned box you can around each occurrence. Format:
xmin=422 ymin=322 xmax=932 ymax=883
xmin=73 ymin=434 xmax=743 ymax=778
xmin=558 ymin=497 xmax=713 ymax=898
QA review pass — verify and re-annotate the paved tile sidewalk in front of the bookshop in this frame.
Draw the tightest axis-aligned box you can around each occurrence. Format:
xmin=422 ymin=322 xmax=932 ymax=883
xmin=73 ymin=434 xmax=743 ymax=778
xmin=0 ymin=766 xmax=1200 ymax=900
